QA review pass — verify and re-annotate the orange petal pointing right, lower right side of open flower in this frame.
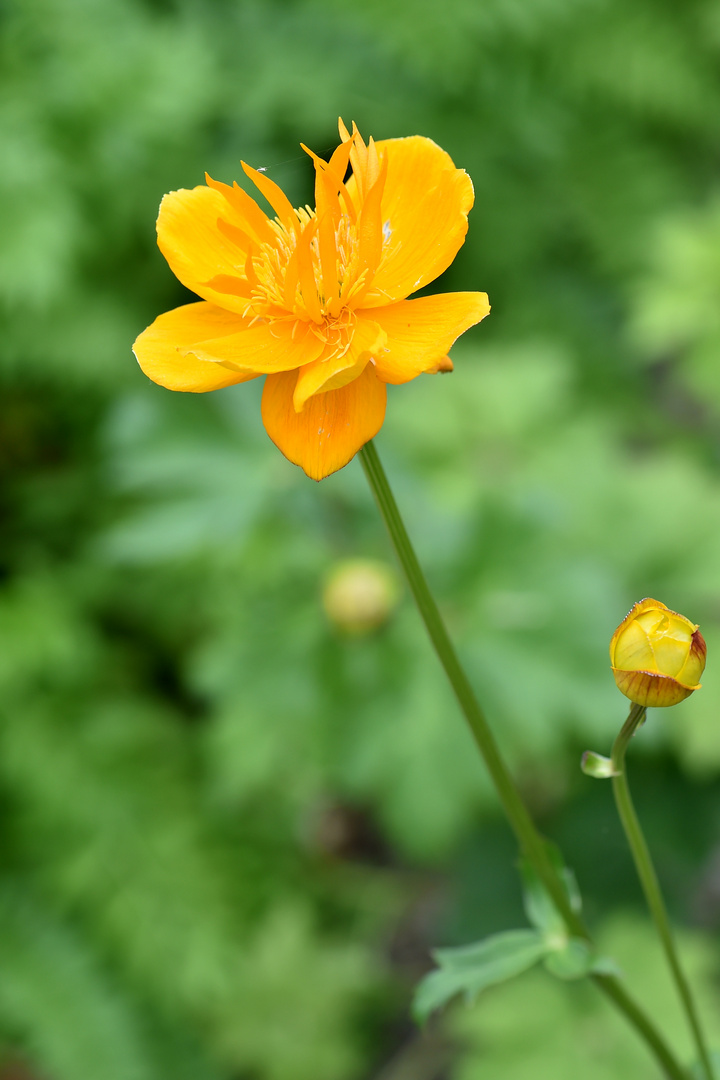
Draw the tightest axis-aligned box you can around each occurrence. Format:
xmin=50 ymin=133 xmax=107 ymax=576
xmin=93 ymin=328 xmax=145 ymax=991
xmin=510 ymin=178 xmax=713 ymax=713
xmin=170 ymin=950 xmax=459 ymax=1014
xmin=367 ymin=293 xmax=490 ymax=383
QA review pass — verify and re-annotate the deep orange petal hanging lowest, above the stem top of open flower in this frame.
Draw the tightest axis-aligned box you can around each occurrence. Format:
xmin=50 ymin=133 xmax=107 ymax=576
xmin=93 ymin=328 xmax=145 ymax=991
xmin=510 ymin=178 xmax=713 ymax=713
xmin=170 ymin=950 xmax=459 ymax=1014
xmin=262 ymin=364 xmax=386 ymax=480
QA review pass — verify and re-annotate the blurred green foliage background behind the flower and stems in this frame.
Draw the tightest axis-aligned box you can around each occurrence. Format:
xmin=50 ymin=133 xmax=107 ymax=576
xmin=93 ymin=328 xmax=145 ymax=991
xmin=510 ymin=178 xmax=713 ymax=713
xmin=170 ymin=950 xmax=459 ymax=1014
xmin=0 ymin=0 xmax=720 ymax=1080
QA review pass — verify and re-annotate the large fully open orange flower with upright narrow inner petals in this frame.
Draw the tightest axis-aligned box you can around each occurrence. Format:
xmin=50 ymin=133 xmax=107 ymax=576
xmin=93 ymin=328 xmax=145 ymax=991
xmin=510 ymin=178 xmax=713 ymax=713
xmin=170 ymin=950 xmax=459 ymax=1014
xmin=133 ymin=121 xmax=490 ymax=480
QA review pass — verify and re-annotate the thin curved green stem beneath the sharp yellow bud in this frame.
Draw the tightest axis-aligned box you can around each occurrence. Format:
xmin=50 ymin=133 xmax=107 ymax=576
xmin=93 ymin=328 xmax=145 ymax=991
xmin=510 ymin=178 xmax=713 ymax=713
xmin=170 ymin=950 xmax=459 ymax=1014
xmin=611 ymin=704 xmax=715 ymax=1080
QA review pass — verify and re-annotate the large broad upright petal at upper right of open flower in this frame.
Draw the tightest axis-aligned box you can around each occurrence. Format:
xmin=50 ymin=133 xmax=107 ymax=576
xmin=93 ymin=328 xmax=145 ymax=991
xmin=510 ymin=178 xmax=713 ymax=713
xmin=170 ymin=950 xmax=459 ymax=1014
xmin=348 ymin=135 xmax=475 ymax=308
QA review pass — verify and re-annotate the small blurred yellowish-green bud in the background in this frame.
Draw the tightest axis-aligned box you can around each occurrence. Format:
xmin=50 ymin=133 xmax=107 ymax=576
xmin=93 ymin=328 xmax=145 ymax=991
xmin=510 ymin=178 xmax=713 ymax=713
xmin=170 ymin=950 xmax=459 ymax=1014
xmin=323 ymin=558 xmax=399 ymax=634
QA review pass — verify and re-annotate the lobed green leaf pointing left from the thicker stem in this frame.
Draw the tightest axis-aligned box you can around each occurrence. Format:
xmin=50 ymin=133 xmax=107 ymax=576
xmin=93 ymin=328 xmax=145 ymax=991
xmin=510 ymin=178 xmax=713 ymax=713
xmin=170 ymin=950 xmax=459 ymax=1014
xmin=412 ymin=930 xmax=548 ymax=1023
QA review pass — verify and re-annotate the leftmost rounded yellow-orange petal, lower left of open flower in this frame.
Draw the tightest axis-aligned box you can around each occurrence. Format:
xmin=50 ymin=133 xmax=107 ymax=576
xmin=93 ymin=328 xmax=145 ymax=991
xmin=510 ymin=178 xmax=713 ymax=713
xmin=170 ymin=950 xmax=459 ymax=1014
xmin=133 ymin=300 xmax=255 ymax=393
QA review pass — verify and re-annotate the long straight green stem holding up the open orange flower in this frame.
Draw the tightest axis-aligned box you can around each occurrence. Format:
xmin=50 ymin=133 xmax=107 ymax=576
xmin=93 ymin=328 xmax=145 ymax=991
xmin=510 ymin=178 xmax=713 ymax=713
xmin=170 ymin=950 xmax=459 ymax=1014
xmin=359 ymin=442 xmax=688 ymax=1080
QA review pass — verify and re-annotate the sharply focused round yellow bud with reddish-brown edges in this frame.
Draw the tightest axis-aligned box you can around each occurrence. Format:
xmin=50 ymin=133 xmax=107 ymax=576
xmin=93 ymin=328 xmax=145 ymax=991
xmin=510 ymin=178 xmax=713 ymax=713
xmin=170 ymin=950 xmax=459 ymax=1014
xmin=610 ymin=599 xmax=707 ymax=707
